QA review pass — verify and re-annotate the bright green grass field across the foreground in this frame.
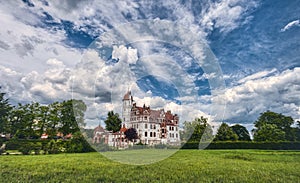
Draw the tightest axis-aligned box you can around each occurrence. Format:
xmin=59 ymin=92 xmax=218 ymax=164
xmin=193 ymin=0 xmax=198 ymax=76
xmin=0 ymin=150 xmax=300 ymax=183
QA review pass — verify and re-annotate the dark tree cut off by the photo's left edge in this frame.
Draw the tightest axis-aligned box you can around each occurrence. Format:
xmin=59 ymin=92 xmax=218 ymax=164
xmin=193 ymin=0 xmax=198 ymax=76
xmin=0 ymin=90 xmax=12 ymax=133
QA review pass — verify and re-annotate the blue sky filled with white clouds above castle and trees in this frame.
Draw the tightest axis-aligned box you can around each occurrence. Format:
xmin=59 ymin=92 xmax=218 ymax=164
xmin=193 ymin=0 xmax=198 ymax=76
xmin=0 ymin=0 xmax=300 ymax=132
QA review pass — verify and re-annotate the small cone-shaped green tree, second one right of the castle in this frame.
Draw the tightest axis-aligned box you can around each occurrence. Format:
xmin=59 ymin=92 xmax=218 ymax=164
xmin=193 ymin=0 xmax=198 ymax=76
xmin=214 ymin=123 xmax=239 ymax=141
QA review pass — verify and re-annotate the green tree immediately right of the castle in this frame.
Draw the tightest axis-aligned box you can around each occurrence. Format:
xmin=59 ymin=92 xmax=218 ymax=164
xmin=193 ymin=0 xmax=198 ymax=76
xmin=181 ymin=116 xmax=213 ymax=142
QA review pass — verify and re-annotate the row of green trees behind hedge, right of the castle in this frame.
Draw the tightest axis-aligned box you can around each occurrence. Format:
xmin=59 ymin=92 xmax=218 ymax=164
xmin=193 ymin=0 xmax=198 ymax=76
xmin=181 ymin=111 xmax=300 ymax=142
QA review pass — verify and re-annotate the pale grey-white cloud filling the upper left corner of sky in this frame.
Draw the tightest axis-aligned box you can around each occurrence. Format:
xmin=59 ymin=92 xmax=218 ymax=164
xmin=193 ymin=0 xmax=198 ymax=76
xmin=0 ymin=1 xmax=81 ymax=73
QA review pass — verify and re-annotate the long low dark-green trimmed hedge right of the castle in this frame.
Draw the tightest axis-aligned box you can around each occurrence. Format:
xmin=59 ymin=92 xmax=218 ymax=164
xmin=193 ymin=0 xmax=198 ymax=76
xmin=182 ymin=141 xmax=300 ymax=150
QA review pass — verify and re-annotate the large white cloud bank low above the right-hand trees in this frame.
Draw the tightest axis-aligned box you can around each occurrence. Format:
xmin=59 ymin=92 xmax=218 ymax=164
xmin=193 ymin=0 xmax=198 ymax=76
xmin=214 ymin=67 xmax=300 ymax=123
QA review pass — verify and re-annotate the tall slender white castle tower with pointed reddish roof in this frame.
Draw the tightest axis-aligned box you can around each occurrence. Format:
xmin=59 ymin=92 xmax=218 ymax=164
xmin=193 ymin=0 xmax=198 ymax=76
xmin=122 ymin=91 xmax=133 ymax=128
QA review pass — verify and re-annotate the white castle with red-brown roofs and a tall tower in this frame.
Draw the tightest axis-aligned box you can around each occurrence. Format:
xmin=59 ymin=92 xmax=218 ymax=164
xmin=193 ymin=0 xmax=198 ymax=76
xmin=93 ymin=91 xmax=180 ymax=148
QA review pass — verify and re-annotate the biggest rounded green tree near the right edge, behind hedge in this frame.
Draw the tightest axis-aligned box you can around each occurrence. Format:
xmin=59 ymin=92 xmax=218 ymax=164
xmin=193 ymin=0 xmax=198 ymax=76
xmin=253 ymin=111 xmax=296 ymax=141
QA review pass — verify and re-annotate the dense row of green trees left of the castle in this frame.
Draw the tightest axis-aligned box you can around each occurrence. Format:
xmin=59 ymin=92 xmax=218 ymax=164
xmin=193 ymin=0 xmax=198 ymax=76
xmin=0 ymin=90 xmax=86 ymax=139
